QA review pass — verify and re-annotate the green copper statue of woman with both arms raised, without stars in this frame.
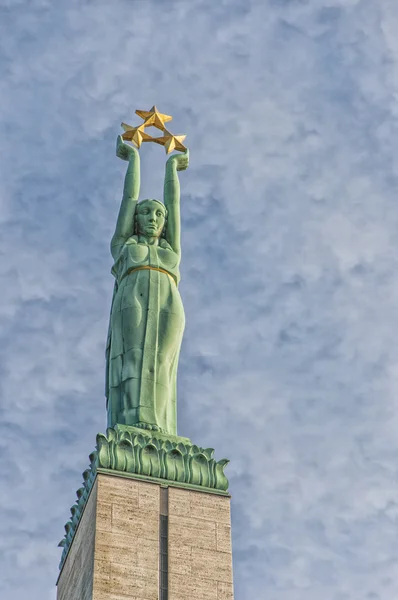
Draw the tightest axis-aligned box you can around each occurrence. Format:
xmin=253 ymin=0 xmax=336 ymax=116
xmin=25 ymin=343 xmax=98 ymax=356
xmin=106 ymin=136 xmax=189 ymax=435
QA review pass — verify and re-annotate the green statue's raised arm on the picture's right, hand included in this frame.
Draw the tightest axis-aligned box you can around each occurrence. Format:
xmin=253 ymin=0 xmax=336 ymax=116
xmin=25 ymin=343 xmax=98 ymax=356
xmin=164 ymin=150 xmax=189 ymax=255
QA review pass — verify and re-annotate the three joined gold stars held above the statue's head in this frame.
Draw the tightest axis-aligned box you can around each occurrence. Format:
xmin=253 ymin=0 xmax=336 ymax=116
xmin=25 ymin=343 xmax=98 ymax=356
xmin=122 ymin=106 xmax=187 ymax=154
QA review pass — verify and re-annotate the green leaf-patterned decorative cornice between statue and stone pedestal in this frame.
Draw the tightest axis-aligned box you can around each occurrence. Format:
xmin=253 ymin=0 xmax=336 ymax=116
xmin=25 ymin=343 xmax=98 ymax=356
xmin=59 ymin=425 xmax=229 ymax=569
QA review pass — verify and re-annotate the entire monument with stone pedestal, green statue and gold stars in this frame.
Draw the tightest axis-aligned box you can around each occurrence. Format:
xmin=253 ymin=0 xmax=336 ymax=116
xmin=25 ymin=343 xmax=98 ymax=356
xmin=57 ymin=106 xmax=233 ymax=600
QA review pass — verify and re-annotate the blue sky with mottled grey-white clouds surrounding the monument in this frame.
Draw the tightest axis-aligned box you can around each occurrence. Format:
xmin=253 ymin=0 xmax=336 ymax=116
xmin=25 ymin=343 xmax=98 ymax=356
xmin=0 ymin=0 xmax=398 ymax=600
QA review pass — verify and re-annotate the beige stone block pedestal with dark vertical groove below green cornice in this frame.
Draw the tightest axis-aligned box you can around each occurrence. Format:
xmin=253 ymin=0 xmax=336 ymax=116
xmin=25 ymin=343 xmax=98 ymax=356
xmin=57 ymin=469 xmax=233 ymax=600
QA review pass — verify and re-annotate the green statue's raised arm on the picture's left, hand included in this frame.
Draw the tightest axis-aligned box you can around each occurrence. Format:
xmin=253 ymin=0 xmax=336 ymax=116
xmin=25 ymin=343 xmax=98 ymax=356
xmin=111 ymin=135 xmax=140 ymax=260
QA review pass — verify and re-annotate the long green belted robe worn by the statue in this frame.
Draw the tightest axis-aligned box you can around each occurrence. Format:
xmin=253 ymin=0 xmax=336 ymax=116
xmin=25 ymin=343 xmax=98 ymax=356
xmin=106 ymin=236 xmax=185 ymax=434
